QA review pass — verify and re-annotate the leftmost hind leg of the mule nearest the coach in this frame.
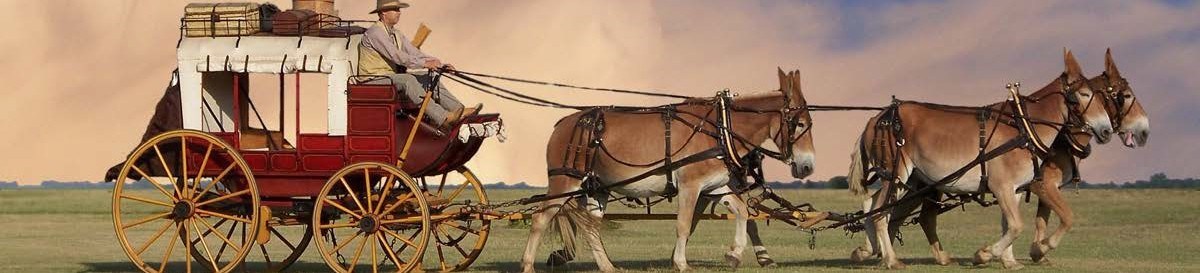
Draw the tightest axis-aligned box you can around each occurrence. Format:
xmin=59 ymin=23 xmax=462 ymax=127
xmin=521 ymin=176 xmax=580 ymax=273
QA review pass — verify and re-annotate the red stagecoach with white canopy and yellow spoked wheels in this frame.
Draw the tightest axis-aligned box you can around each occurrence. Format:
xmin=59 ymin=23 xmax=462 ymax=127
xmin=113 ymin=16 xmax=502 ymax=272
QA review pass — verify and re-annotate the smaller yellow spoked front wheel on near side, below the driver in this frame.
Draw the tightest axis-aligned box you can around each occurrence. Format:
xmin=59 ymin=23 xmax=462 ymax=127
xmin=312 ymin=163 xmax=432 ymax=272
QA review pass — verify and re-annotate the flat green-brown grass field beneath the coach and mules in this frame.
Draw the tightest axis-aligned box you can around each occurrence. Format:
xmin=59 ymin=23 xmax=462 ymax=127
xmin=0 ymin=189 xmax=1200 ymax=273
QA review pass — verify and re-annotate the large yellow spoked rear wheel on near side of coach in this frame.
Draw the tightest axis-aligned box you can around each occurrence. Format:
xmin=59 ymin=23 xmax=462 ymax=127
xmin=113 ymin=131 xmax=259 ymax=272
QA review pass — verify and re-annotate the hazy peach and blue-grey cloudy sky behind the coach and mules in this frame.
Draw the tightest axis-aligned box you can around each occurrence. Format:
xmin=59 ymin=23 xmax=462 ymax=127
xmin=0 ymin=0 xmax=1200 ymax=184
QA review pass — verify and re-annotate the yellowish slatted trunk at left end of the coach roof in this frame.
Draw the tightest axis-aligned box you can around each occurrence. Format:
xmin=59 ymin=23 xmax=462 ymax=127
xmin=184 ymin=2 xmax=262 ymax=37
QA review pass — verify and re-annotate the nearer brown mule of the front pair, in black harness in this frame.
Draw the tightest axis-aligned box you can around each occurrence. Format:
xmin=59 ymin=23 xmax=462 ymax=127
xmin=850 ymin=51 xmax=1112 ymax=268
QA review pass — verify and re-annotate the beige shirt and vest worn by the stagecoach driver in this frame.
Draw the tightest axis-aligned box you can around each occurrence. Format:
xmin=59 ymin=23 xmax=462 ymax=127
xmin=359 ymin=22 xmax=437 ymax=75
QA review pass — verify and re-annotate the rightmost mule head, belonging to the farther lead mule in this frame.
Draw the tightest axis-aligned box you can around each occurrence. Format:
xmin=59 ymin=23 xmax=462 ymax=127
xmin=1091 ymin=49 xmax=1150 ymax=147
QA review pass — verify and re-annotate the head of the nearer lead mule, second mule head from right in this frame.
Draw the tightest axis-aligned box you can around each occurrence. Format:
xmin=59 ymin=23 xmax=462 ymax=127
xmin=1062 ymin=50 xmax=1112 ymax=144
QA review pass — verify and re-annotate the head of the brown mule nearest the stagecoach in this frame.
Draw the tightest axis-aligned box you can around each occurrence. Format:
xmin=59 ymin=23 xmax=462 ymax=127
xmin=772 ymin=69 xmax=816 ymax=178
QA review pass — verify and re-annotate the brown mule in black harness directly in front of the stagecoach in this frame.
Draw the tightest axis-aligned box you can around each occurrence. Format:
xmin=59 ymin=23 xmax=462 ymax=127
xmin=521 ymin=71 xmax=814 ymax=272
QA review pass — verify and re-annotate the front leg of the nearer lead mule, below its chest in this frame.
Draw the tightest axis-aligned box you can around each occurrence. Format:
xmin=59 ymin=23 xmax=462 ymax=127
xmin=974 ymin=183 xmax=1022 ymax=269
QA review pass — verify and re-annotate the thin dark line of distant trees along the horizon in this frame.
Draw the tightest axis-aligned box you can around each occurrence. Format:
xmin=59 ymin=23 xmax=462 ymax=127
xmin=7 ymin=172 xmax=1200 ymax=189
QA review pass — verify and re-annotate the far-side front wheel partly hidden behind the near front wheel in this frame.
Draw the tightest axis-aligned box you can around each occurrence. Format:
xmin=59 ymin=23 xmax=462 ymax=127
xmin=421 ymin=166 xmax=492 ymax=272
